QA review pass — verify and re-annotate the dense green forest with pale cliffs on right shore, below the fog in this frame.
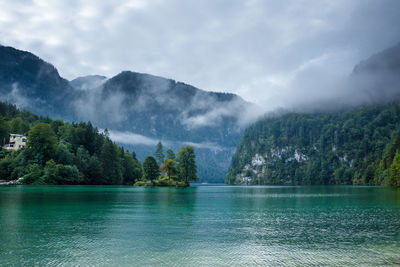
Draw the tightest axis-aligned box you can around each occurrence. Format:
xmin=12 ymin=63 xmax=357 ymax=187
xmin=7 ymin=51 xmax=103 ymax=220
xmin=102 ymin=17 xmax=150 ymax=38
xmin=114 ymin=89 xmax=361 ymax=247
xmin=226 ymin=103 xmax=400 ymax=186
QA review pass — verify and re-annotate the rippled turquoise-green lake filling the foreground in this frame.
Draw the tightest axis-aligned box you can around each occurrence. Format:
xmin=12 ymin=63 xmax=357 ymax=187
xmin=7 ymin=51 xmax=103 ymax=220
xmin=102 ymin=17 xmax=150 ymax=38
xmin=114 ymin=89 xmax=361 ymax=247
xmin=0 ymin=186 xmax=400 ymax=266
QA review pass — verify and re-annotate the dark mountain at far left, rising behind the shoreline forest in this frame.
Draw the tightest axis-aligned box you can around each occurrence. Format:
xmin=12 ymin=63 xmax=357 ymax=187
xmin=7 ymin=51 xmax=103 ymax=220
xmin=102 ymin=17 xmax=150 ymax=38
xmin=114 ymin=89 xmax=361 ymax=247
xmin=0 ymin=45 xmax=73 ymax=116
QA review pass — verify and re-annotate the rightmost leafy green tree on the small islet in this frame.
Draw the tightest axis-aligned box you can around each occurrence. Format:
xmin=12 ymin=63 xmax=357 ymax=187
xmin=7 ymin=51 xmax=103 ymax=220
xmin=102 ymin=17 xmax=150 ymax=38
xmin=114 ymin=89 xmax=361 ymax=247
xmin=178 ymin=146 xmax=199 ymax=183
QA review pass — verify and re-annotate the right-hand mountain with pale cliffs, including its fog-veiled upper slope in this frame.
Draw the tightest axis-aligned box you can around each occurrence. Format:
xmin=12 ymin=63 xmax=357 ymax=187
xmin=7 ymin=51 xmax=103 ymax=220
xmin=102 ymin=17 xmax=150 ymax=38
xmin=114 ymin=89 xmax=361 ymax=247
xmin=226 ymin=45 xmax=400 ymax=186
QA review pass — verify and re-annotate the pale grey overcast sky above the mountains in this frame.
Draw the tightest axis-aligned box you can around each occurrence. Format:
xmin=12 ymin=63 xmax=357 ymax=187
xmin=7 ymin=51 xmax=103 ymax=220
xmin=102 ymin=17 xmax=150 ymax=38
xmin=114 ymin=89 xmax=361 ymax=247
xmin=0 ymin=0 xmax=400 ymax=109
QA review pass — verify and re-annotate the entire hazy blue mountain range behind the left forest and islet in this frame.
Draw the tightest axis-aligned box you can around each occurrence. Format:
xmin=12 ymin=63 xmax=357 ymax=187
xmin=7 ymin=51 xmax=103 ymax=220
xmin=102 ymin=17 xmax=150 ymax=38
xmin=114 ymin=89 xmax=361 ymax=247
xmin=0 ymin=46 xmax=257 ymax=182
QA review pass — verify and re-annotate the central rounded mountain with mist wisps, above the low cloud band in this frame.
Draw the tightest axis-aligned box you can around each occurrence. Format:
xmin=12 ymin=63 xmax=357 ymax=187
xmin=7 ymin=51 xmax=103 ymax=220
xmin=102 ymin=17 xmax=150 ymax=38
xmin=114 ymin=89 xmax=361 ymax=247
xmin=74 ymin=71 xmax=250 ymax=146
